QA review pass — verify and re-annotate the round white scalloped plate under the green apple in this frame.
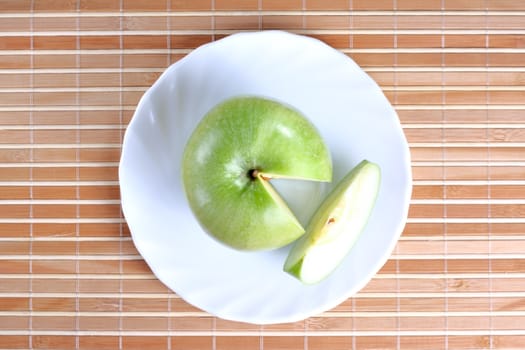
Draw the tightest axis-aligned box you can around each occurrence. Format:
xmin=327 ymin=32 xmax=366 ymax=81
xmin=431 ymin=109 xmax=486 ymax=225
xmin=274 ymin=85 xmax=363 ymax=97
xmin=119 ymin=31 xmax=412 ymax=324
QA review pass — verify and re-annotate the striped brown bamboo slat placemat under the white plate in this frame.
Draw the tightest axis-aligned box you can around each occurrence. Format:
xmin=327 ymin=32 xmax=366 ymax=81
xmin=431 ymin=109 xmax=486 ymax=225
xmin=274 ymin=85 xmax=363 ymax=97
xmin=0 ymin=0 xmax=525 ymax=350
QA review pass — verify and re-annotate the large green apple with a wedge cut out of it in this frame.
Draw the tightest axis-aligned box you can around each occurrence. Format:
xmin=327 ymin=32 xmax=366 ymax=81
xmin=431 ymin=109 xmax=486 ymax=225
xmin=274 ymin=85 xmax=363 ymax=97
xmin=182 ymin=97 xmax=332 ymax=250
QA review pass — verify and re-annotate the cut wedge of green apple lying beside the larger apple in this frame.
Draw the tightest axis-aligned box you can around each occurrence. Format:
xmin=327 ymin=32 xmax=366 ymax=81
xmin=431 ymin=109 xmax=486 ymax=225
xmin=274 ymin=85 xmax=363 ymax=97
xmin=284 ymin=160 xmax=381 ymax=284
